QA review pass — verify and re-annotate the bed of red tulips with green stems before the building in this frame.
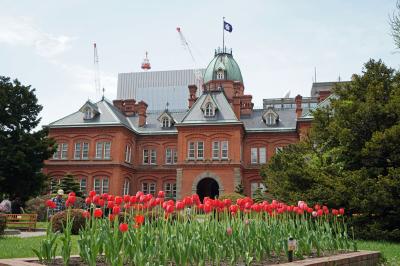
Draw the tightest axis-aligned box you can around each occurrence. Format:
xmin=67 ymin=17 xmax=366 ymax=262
xmin=36 ymin=191 xmax=356 ymax=265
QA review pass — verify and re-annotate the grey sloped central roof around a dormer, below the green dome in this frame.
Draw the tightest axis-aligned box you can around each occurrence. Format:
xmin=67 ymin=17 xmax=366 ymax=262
xmin=180 ymin=91 xmax=240 ymax=124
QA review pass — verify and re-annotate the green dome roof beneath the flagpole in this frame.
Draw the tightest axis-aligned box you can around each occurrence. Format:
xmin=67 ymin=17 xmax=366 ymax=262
xmin=203 ymin=49 xmax=243 ymax=83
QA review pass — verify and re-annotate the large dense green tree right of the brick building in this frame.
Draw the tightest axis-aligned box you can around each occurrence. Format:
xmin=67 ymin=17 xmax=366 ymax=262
xmin=262 ymin=60 xmax=400 ymax=240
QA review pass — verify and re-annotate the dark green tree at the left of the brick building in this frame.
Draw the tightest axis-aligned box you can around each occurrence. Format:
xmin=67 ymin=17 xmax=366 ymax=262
xmin=0 ymin=76 xmax=55 ymax=200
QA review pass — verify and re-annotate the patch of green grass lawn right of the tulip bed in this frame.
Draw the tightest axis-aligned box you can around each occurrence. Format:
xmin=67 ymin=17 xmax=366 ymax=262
xmin=357 ymin=241 xmax=400 ymax=266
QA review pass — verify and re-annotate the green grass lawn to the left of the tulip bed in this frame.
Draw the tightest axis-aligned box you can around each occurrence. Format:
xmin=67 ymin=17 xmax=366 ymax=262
xmin=0 ymin=236 xmax=79 ymax=259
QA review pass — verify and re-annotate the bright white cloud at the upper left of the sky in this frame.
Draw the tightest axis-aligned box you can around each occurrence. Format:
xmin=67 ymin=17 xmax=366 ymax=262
xmin=0 ymin=16 xmax=74 ymax=57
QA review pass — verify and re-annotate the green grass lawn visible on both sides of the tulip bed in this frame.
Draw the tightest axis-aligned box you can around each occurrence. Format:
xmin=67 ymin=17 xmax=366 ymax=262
xmin=0 ymin=236 xmax=400 ymax=265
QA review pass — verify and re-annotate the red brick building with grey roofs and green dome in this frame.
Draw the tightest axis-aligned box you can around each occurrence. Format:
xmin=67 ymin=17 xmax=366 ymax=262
xmin=44 ymin=48 xmax=325 ymax=201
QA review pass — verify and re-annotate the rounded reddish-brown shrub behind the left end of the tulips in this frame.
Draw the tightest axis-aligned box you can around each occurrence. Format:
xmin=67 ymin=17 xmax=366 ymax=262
xmin=51 ymin=209 xmax=86 ymax=235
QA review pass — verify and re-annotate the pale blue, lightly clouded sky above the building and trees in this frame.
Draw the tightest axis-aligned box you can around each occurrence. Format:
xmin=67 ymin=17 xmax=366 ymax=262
xmin=0 ymin=0 xmax=400 ymax=126
